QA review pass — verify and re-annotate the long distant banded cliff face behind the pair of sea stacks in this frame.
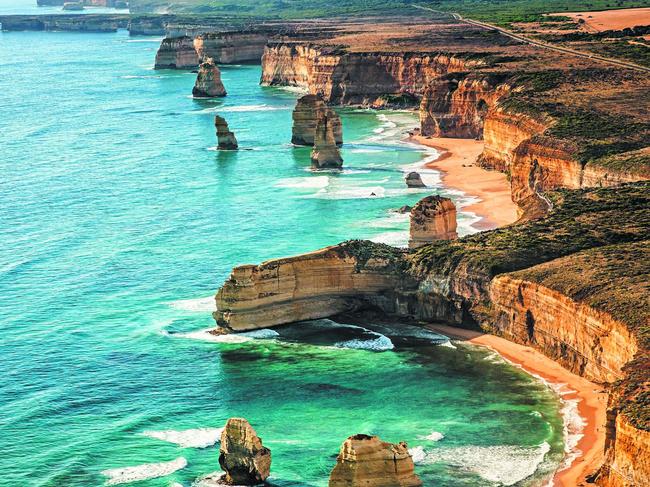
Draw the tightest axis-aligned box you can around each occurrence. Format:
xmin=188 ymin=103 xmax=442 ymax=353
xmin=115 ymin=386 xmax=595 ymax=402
xmin=261 ymin=42 xmax=482 ymax=105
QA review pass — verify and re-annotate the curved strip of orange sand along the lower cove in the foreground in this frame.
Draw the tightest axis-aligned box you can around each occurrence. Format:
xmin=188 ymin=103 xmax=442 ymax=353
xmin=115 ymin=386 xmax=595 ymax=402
xmin=427 ymin=325 xmax=607 ymax=487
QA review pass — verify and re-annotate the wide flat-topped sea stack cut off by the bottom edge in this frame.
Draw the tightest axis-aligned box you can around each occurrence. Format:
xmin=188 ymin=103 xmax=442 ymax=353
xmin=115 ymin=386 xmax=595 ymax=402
xmin=329 ymin=435 xmax=422 ymax=487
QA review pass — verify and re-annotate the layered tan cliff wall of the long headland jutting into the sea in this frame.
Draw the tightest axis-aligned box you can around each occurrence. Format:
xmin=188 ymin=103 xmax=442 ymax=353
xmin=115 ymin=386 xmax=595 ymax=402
xmin=214 ymin=243 xmax=401 ymax=330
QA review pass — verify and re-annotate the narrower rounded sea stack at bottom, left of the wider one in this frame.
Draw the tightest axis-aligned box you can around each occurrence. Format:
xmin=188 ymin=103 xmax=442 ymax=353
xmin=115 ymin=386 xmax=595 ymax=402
xmin=219 ymin=418 xmax=271 ymax=485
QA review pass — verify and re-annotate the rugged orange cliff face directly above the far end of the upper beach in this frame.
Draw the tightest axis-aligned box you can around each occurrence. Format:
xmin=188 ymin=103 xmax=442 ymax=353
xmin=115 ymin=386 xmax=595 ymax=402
xmin=420 ymin=75 xmax=511 ymax=139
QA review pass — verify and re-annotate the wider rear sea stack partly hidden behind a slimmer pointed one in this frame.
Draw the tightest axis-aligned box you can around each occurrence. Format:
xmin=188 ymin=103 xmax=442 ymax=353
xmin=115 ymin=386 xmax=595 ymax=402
xmin=291 ymin=95 xmax=343 ymax=146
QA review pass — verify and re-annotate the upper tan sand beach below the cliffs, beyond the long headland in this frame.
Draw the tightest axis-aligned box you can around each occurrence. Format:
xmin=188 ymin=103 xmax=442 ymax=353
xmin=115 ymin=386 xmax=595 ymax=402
xmin=409 ymin=135 xmax=517 ymax=230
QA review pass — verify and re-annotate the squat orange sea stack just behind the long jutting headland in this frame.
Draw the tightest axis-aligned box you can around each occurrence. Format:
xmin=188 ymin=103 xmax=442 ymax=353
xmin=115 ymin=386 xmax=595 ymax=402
xmin=409 ymin=195 xmax=458 ymax=249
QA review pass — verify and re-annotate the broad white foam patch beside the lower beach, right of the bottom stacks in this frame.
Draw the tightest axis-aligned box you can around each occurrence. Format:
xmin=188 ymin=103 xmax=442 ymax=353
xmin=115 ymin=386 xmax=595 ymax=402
xmin=419 ymin=442 xmax=551 ymax=485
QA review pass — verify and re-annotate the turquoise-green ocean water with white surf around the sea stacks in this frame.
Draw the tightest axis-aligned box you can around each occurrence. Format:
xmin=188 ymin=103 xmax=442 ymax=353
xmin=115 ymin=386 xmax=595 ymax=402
xmin=0 ymin=28 xmax=568 ymax=487
